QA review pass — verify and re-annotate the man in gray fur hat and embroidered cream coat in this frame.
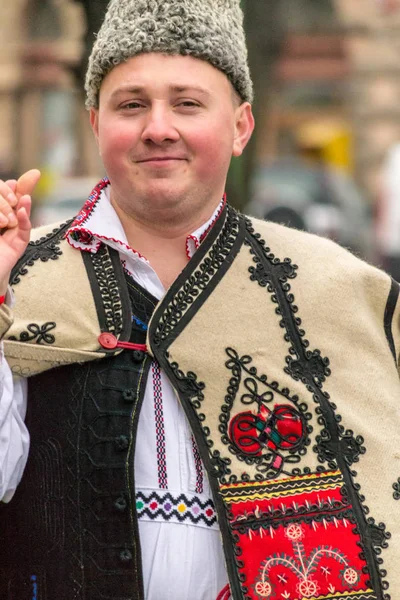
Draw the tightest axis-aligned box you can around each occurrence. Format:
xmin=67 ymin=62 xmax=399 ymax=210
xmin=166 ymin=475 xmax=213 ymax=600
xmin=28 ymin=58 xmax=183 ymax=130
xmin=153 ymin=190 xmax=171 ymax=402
xmin=0 ymin=0 xmax=400 ymax=600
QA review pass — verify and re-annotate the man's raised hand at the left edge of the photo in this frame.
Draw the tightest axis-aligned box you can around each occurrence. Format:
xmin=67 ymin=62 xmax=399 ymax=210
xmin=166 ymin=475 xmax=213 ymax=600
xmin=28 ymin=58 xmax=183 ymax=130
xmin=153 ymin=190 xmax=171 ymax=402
xmin=0 ymin=169 xmax=40 ymax=296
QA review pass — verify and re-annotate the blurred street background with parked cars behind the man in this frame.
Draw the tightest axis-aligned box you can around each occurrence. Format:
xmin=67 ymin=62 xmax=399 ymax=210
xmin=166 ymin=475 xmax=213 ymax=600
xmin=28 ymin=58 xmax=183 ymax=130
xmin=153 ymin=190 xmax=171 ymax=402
xmin=0 ymin=0 xmax=400 ymax=280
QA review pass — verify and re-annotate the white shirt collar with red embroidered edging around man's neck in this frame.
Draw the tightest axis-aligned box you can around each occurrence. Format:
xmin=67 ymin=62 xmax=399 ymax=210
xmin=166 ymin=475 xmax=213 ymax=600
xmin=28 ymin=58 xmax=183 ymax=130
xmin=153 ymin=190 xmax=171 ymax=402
xmin=66 ymin=178 xmax=226 ymax=262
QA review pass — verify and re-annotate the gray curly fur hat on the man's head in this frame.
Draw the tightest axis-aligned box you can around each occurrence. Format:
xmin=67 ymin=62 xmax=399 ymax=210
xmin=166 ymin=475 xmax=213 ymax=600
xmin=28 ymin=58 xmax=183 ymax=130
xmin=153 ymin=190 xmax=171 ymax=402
xmin=85 ymin=0 xmax=253 ymax=108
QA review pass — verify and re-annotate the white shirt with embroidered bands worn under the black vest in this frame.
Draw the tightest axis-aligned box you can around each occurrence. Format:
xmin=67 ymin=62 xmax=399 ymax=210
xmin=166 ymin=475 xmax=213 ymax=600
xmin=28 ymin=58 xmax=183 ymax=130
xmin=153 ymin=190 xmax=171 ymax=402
xmin=0 ymin=181 xmax=228 ymax=600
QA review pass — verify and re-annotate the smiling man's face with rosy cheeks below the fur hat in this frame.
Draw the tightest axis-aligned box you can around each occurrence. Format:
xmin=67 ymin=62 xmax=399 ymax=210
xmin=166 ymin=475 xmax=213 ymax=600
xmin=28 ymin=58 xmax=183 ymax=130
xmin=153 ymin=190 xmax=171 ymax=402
xmin=91 ymin=53 xmax=253 ymax=223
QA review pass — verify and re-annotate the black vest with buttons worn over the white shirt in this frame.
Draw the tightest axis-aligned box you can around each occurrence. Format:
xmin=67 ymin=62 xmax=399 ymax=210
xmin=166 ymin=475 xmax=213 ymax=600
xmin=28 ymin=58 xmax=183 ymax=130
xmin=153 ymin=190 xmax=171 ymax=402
xmin=0 ymin=278 xmax=156 ymax=600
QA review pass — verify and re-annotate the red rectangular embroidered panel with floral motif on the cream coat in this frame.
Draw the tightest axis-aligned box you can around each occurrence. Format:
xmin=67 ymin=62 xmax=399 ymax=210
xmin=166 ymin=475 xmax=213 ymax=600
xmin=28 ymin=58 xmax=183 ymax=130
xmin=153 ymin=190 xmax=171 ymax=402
xmin=222 ymin=471 xmax=376 ymax=600
